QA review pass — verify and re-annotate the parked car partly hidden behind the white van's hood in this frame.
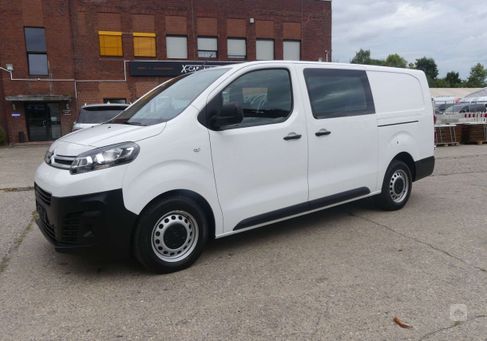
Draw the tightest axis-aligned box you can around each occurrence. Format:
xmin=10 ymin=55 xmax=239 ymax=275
xmin=73 ymin=103 xmax=129 ymax=131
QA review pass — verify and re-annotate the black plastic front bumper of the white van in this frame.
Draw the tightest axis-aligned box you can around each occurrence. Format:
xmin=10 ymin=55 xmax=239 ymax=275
xmin=35 ymin=184 xmax=137 ymax=255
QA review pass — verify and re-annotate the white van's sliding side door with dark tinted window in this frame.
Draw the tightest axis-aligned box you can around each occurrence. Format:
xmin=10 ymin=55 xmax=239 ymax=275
xmin=302 ymin=68 xmax=378 ymax=201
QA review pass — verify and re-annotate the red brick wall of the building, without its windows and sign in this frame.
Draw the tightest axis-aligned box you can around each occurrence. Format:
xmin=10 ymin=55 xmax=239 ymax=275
xmin=0 ymin=0 xmax=331 ymax=143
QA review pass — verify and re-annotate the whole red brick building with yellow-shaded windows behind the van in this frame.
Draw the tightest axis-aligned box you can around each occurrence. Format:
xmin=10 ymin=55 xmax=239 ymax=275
xmin=0 ymin=0 xmax=331 ymax=143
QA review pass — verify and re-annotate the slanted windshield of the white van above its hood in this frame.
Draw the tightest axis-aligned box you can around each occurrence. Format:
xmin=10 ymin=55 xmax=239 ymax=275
xmin=111 ymin=68 xmax=229 ymax=126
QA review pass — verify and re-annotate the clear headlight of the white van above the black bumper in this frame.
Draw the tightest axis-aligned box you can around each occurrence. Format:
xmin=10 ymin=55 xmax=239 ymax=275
xmin=70 ymin=142 xmax=140 ymax=174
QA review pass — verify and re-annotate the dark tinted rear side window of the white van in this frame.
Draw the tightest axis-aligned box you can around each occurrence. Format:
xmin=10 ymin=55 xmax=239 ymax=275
xmin=304 ymin=69 xmax=375 ymax=119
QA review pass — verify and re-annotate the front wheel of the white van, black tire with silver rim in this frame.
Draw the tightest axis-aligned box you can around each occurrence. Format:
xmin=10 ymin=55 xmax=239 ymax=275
xmin=133 ymin=196 xmax=209 ymax=273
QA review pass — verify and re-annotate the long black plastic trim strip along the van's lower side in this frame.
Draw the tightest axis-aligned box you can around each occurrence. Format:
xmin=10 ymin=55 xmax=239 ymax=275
xmin=233 ymin=187 xmax=370 ymax=231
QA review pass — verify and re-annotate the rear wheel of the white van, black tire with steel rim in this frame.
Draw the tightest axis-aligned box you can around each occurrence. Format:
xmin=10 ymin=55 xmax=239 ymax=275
xmin=376 ymin=160 xmax=413 ymax=211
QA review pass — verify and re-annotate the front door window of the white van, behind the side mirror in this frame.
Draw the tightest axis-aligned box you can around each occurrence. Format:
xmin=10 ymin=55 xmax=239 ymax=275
xmin=207 ymin=69 xmax=293 ymax=129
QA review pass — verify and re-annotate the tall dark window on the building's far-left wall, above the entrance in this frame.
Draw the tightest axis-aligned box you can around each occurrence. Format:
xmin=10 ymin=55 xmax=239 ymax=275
xmin=24 ymin=27 xmax=49 ymax=76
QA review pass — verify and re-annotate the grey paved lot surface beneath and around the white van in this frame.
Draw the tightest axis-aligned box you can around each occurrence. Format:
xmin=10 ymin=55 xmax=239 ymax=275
xmin=0 ymin=145 xmax=487 ymax=340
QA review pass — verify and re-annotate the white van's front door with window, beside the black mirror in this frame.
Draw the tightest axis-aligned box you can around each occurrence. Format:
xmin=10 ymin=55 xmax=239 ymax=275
xmin=206 ymin=68 xmax=308 ymax=232
